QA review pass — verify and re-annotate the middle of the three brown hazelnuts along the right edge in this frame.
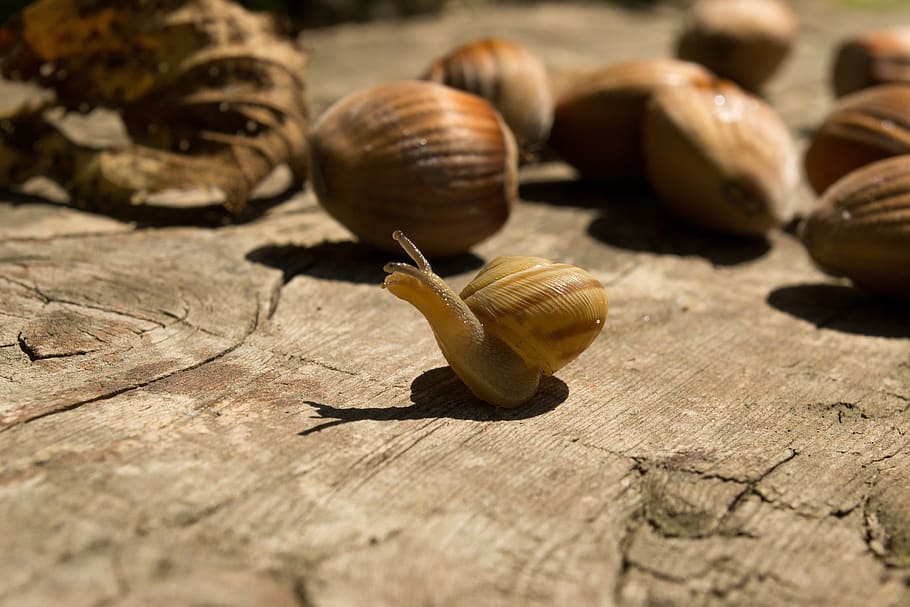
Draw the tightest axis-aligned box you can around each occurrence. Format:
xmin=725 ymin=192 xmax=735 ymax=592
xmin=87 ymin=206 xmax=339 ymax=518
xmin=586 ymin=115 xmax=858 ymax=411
xmin=805 ymin=84 xmax=910 ymax=194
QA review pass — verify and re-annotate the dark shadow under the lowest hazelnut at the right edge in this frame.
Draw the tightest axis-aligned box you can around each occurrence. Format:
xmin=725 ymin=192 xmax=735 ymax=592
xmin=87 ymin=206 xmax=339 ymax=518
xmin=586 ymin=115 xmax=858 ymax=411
xmin=767 ymin=284 xmax=910 ymax=339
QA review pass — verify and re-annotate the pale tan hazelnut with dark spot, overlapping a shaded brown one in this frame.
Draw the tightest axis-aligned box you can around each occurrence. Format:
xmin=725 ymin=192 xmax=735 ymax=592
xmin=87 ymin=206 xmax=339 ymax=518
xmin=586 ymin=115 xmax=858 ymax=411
xmin=643 ymin=81 xmax=799 ymax=236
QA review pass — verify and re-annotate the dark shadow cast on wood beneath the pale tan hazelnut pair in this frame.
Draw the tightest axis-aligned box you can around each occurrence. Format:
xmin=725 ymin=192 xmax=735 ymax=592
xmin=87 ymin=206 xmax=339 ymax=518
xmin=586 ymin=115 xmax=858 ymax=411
xmin=521 ymin=179 xmax=771 ymax=266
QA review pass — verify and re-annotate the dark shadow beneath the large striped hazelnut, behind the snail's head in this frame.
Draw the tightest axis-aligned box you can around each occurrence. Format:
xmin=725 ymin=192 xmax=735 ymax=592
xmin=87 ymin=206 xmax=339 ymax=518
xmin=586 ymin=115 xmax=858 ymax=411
xmin=246 ymin=241 xmax=484 ymax=284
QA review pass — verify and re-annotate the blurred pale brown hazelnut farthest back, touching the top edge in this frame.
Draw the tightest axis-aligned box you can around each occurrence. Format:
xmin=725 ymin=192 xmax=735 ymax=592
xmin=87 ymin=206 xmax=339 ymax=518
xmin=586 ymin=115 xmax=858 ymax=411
xmin=676 ymin=0 xmax=798 ymax=90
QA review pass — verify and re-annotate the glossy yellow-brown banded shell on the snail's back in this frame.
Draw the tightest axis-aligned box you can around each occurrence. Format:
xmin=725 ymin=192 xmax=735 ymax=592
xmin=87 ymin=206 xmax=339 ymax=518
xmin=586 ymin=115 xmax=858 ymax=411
xmin=461 ymin=257 xmax=607 ymax=375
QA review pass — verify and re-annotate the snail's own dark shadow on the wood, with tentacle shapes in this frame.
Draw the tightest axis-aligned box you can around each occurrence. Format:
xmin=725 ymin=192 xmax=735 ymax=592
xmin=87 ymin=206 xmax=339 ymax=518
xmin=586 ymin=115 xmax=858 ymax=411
xmin=298 ymin=367 xmax=569 ymax=436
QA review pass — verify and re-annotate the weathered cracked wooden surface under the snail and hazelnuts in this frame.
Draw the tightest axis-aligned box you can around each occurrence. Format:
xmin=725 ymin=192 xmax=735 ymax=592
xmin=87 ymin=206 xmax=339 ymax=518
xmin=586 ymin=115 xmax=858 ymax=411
xmin=0 ymin=2 xmax=910 ymax=607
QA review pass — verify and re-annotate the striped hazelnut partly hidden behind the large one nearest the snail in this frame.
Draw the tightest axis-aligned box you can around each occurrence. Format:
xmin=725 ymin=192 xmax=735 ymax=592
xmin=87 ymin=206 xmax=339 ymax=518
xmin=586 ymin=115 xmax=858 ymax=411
xmin=423 ymin=38 xmax=553 ymax=153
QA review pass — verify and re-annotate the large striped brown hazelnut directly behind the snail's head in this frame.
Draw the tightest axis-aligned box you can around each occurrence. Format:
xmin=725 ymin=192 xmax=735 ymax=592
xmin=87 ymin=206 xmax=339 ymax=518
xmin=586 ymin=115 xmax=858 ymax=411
xmin=309 ymin=81 xmax=518 ymax=256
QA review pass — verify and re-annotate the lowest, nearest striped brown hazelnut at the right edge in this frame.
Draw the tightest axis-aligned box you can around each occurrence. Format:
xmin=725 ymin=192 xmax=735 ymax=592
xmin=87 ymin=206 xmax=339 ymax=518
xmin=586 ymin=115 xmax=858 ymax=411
xmin=800 ymin=156 xmax=910 ymax=296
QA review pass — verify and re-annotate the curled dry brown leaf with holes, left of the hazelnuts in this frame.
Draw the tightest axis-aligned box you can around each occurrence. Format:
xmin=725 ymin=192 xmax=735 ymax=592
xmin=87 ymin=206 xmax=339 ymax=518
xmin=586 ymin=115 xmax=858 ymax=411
xmin=0 ymin=0 xmax=307 ymax=218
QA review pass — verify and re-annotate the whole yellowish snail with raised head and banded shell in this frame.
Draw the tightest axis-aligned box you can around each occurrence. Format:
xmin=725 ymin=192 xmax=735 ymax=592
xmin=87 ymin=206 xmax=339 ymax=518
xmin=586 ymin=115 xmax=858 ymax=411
xmin=383 ymin=231 xmax=607 ymax=407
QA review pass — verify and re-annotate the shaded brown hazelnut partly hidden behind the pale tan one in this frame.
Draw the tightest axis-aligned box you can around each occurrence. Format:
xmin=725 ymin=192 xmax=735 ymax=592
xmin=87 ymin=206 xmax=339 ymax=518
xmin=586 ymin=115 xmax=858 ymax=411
xmin=550 ymin=59 xmax=714 ymax=184
